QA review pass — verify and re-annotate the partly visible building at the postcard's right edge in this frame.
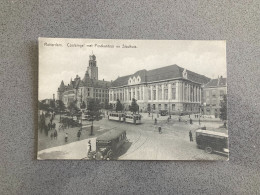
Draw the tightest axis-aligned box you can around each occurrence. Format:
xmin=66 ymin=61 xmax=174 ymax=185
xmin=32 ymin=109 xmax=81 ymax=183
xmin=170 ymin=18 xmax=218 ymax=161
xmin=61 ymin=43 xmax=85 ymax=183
xmin=202 ymin=76 xmax=227 ymax=118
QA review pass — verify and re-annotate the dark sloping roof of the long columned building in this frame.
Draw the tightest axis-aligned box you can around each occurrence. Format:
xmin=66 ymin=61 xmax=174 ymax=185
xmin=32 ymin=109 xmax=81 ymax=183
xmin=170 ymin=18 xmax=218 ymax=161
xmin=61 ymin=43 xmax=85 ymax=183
xmin=111 ymin=64 xmax=210 ymax=87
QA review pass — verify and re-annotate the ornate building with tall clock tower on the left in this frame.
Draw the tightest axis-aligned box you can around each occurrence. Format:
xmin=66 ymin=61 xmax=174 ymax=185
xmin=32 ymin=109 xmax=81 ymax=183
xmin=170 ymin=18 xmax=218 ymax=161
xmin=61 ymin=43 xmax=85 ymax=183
xmin=58 ymin=55 xmax=111 ymax=107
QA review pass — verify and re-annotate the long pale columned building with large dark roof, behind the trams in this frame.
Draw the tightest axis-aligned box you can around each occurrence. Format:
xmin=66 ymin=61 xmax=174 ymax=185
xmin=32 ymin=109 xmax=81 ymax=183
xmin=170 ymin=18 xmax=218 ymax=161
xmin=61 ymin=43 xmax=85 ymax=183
xmin=109 ymin=65 xmax=210 ymax=113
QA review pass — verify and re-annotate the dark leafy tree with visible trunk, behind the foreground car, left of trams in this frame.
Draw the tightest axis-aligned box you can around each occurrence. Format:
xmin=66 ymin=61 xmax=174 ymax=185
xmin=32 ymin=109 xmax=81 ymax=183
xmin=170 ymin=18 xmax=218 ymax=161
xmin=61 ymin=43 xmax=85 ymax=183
xmin=87 ymin=98 xmax=101 ymax=135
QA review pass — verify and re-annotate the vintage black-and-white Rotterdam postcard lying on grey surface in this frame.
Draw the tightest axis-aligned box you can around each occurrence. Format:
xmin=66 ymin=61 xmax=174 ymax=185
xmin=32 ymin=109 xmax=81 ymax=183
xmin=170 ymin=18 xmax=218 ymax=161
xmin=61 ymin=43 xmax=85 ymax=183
xmin=37 ymin=38 xmax=229 ymax=160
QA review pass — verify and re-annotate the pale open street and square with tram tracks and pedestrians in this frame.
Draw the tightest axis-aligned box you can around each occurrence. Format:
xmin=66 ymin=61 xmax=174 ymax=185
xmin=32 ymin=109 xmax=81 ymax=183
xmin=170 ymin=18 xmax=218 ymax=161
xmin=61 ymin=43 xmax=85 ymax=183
xmin=39 ymin=114 xmax=228 ymax=160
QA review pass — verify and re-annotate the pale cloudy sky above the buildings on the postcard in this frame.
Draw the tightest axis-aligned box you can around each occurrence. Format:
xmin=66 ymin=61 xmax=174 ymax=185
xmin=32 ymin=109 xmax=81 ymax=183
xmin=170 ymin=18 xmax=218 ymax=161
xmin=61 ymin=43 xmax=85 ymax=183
xmin=38 ymin=38 xmax=227 ymax=100
